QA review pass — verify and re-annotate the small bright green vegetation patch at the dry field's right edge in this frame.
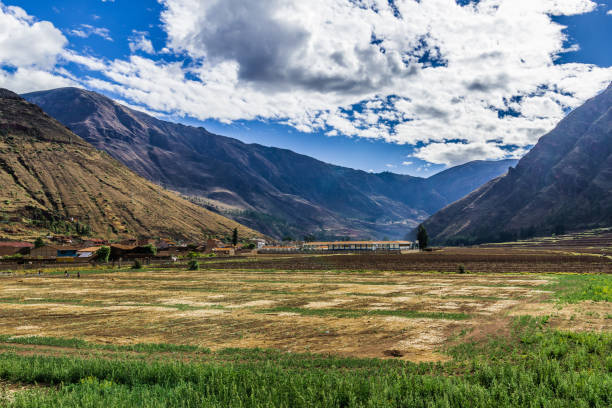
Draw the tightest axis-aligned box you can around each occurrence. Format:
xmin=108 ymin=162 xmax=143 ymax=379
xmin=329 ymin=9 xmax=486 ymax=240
xmin=546 ymin=274 xmax=612 ymax=303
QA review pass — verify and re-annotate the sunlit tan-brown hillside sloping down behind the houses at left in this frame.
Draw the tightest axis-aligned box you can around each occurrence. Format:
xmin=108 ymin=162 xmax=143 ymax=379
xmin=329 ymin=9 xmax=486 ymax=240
xmin=0 ymin=89 xmax=259 ymax=239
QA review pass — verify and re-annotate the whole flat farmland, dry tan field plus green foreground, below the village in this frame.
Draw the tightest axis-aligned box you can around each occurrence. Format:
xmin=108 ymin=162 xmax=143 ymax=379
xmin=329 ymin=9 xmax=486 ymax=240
xmin=0 ymin=245 xmax=612 ymax=407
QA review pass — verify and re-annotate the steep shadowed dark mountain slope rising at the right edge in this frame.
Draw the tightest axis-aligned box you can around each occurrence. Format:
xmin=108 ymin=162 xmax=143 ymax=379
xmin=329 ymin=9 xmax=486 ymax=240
xmin=425 ymin=84 xmax=612 ymax=243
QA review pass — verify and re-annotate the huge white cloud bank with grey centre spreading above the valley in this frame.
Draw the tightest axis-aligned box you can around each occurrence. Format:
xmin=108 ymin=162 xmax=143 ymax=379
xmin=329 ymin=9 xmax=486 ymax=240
xmin=0 ymin=0 xmax=612 ymax=165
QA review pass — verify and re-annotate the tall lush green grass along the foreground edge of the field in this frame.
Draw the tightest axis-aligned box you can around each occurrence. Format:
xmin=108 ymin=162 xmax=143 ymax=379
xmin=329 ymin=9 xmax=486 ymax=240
xmin=0 ymin=317 xmax=612 ymax=408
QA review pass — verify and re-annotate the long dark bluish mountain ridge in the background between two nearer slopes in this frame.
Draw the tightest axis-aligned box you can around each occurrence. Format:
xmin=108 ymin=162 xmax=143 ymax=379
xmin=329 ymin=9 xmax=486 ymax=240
xmin=24 ymin=88 xmax=514 ymax=238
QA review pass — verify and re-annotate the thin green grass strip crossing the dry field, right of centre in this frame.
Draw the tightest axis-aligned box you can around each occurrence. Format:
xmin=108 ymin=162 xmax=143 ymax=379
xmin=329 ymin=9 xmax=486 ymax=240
xmin=258 ymin=307 xmax=470 ymax=320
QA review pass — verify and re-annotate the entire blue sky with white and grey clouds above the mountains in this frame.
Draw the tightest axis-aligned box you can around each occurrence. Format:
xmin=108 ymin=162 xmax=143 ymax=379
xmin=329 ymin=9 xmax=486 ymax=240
xmin=0 ymin=0 xmax=612 ymax=176
